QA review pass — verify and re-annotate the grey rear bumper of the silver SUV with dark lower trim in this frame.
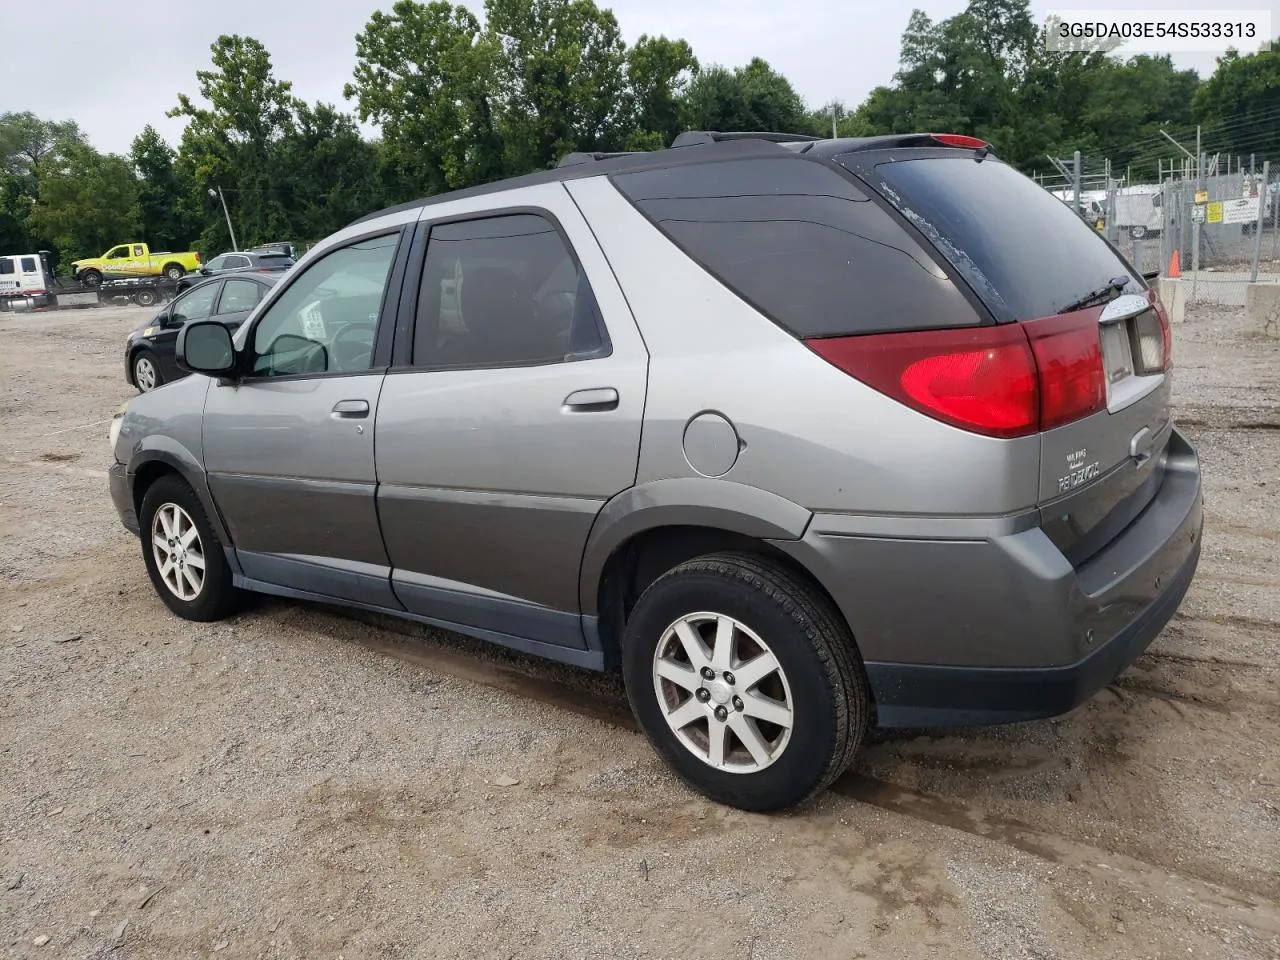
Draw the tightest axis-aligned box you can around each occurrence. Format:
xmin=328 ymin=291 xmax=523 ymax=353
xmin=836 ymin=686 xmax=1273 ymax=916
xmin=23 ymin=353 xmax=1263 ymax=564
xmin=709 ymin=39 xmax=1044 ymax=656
xmin=776 ymin=429 xmax=1203 ymax=727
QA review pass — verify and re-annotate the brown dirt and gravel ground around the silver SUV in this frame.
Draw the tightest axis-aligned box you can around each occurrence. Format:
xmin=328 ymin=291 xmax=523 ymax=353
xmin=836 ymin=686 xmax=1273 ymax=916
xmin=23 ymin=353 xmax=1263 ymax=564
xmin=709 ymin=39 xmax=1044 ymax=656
xmin=0 ymin=302 xmax=1280 ymax=960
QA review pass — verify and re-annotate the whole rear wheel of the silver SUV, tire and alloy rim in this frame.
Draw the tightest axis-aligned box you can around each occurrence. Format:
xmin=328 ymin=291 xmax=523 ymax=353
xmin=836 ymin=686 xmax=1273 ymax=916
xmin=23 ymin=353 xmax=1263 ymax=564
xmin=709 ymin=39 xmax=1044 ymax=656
xmin=622 ymin=553 xmax=870 ymax=813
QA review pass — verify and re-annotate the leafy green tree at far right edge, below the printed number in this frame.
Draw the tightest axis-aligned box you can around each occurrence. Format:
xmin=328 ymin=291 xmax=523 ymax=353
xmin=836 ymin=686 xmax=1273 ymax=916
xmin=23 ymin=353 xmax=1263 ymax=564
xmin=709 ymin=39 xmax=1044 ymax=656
xmin=1192 ymin=44 xmax=1280 ymax=154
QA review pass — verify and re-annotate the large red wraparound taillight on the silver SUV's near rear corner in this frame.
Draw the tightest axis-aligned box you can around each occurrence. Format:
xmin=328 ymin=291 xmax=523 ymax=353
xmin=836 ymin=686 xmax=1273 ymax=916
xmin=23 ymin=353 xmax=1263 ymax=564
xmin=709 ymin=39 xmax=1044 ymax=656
xmin=805 ymin=310 xmax=1106 ymax=438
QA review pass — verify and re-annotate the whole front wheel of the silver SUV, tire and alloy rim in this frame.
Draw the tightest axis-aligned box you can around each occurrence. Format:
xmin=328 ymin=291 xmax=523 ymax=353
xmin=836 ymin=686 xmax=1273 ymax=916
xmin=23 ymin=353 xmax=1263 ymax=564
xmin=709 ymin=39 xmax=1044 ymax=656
xmin=138 ymin=474 xmax=243 ymax=622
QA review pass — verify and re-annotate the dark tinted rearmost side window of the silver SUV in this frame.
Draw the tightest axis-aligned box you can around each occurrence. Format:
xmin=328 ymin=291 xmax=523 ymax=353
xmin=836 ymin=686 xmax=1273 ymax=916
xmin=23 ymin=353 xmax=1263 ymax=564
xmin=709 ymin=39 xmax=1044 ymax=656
xmin=613 ymin=159 xmax=978 ymax=337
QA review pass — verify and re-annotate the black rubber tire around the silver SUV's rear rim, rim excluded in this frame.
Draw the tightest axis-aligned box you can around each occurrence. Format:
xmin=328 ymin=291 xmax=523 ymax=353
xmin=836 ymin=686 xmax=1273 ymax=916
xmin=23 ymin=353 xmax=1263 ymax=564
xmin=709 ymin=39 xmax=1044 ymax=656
xmin=622 ymin=553 xmax=870 ymax=812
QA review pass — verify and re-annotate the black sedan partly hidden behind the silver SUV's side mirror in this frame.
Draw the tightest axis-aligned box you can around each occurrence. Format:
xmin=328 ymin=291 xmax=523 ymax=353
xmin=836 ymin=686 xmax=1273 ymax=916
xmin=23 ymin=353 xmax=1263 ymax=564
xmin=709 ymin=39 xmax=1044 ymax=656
xmin=124 ymin=274 xmax=279 ymax=393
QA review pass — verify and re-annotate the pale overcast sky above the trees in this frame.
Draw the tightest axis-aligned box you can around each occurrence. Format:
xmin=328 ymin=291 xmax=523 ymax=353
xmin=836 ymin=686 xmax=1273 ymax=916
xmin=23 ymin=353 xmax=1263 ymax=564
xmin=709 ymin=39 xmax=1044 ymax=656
xmin=0 ymin=0 xmax=1280 ymax=152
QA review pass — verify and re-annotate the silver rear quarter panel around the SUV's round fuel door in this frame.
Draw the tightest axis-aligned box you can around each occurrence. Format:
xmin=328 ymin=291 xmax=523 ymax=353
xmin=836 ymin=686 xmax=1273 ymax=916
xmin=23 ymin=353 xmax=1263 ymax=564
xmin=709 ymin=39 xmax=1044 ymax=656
xmin=566 ymin=178 xmax=1041 ymax=516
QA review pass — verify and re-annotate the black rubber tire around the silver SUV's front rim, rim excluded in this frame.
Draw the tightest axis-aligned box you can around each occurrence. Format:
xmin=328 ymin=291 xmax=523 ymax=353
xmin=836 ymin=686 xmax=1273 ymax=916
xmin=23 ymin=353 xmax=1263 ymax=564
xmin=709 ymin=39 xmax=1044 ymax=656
xmin=138 ymin=474 xmax=244 ymax=622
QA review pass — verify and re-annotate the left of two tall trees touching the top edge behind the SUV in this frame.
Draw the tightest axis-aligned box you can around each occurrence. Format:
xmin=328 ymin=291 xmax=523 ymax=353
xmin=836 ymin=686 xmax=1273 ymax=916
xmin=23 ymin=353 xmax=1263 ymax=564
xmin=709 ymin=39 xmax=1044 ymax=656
xmin=343 ymin=0 xmax=503 ymax=198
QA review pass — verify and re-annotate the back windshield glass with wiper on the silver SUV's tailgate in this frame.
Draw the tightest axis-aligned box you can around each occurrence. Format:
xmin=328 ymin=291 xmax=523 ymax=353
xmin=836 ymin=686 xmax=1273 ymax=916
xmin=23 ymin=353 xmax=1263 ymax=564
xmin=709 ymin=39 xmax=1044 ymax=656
xmin=874 ymin=155 xmax=1144 ymax=320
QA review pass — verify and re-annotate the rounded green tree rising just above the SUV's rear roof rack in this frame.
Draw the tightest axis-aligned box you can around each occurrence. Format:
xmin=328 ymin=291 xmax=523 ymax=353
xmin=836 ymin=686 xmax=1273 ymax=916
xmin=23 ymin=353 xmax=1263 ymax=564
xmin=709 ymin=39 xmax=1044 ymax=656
xmin=686 ymin=58 xmax=809 ymax=133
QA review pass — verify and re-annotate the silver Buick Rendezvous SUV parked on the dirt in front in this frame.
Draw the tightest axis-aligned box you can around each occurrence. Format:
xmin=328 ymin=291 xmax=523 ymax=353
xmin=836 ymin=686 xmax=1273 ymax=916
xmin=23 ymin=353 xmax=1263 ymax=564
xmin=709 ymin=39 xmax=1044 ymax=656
xmin=110 ymin=133 xmax=1202 ymax=810
